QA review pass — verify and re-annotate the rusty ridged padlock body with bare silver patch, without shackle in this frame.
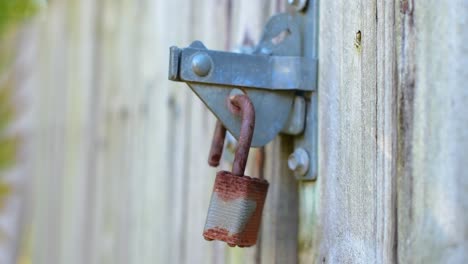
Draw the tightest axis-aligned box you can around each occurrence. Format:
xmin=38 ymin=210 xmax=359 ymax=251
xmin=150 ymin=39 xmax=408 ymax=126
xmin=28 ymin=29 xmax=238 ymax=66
xmin=203 ymin=171 xmax=268 ymax=247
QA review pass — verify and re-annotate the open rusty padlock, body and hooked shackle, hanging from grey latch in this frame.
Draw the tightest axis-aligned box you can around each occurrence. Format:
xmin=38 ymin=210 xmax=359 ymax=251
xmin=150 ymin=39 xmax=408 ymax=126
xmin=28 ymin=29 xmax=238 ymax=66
xmin=203 ymin=95 xmax=268 ymax=247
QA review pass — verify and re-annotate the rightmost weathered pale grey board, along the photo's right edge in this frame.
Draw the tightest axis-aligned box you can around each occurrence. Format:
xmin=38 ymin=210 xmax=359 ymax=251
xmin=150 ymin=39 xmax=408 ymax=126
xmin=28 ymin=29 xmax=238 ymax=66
xmin=398 ymin=1 xmax=468 ymax=263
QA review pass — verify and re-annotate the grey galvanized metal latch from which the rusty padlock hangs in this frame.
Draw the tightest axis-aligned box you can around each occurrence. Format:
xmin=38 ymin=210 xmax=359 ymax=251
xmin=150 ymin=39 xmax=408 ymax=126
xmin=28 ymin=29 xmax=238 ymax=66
xmin=169 ymin=13 xmax=317 ymax=179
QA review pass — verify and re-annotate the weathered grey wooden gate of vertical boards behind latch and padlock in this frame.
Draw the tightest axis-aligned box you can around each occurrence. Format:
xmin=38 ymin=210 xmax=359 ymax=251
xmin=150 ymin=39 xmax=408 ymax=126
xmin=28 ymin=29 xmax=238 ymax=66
xmin=1 ymin=0 xmax=468 ymax=264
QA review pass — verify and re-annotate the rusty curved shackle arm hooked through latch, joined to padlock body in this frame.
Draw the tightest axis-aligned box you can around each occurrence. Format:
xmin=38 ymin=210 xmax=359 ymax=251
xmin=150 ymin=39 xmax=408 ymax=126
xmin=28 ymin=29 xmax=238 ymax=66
xmin=228 ymin=94 xmax=255 ymax=176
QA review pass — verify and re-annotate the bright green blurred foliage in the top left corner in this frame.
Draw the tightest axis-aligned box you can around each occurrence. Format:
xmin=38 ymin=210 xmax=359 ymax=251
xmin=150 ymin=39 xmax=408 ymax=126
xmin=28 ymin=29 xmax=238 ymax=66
xmin=0 ymin=0 xmax=38 ymax=34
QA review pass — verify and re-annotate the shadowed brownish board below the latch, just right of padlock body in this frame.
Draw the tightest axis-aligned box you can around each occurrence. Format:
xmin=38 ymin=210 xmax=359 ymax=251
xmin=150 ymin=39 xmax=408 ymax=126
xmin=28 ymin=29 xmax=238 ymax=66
xmin=261 ymin=136 xmax=298 ymax=263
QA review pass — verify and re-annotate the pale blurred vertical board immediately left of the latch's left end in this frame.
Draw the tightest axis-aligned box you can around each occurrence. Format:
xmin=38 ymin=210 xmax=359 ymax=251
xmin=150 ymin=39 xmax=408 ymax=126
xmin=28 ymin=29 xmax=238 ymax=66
xmin=127 ymin=1 xmax=171 ymax=263
